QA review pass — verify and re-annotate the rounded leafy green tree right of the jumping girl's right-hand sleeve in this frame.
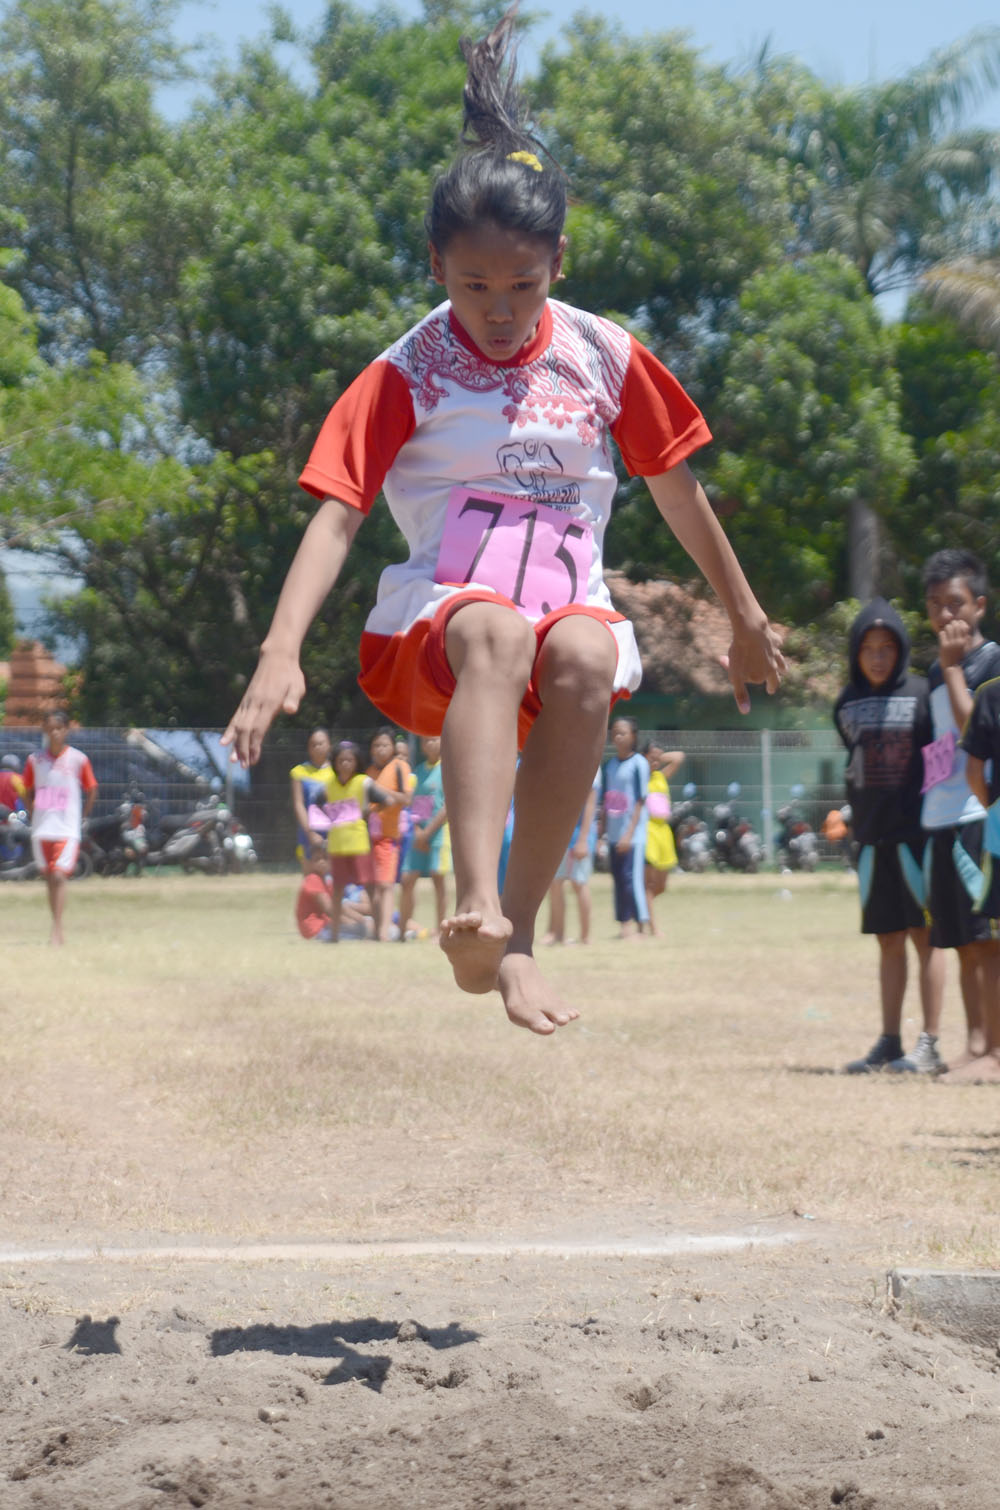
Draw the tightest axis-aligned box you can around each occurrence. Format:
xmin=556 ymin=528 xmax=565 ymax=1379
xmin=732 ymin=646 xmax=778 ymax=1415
xmin=711 ymin=254 xmax=912 ymax=621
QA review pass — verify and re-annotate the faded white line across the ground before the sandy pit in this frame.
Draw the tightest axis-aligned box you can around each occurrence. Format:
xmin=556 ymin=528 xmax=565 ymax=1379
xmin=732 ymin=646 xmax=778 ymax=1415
xmin=0 ymin=1232 xmax=807 ymax=1264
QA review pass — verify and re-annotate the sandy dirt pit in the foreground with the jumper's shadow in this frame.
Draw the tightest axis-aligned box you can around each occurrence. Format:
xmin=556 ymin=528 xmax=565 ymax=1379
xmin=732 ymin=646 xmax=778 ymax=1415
xmin=0 ymin=1234 xmax=1000 ymax=1510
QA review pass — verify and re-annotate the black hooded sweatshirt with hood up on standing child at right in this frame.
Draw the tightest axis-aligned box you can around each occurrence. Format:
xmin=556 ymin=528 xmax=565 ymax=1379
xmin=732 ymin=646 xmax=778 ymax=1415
xmin=834 ymin=598 xmax=934 ymax=844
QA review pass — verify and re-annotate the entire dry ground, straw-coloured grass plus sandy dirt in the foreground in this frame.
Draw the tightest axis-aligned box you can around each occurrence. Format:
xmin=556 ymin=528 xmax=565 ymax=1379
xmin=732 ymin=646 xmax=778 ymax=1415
xmin=0 ymin=874 xmax=1000 ymax=1510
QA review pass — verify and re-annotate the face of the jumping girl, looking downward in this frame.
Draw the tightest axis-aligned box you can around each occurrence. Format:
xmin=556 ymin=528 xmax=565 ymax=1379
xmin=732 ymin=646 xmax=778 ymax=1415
xmin=431 ymin=225 xmax=566 ymax=362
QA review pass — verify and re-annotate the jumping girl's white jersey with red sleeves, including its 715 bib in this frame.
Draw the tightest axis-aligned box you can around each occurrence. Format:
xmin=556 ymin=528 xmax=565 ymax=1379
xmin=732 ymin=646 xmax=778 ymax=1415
xmin=299 ymin=299 xmax=711 ymax=689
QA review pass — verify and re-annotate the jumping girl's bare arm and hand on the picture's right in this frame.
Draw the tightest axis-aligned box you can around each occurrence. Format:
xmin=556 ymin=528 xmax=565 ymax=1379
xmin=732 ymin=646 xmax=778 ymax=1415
xmin=645 ymin=462 xmax=784 ymax=713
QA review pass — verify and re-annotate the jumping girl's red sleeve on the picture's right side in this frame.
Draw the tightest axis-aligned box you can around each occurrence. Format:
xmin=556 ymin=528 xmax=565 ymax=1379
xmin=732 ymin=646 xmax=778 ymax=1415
xmin=612 ymin=337 xmax=711 ymax=477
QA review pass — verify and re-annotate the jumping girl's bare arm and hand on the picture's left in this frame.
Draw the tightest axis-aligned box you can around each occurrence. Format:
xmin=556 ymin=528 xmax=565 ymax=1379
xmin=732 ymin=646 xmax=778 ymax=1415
xmin=222 ymin=498 xmax=364 ymax=766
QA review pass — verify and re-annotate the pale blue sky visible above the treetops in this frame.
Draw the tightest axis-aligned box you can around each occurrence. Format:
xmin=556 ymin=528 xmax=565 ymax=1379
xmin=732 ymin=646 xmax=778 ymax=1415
xmin=164 ymin=0 xmax=1000 ymax=125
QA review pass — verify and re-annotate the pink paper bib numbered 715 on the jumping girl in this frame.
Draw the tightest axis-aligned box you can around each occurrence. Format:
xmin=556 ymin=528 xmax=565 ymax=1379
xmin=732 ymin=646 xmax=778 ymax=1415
xmin=434 ymin=488 xmax=594 ymax=619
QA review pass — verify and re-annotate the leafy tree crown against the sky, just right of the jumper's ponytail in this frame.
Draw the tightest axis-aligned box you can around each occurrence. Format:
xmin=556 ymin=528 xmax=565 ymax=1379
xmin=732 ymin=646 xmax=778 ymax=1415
xmin=533 ymin=17 xmax=793 ymax=353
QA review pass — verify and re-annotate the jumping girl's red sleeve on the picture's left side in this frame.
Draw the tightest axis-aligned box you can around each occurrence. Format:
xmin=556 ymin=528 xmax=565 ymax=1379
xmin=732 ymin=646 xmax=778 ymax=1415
xmin=299 ymin=361 xmax=417 ymax=513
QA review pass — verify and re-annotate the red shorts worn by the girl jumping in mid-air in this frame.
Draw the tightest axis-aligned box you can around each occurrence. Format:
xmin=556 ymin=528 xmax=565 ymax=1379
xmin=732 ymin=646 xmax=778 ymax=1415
xmin=358 ymin=587 xmax=628 ymax=749
